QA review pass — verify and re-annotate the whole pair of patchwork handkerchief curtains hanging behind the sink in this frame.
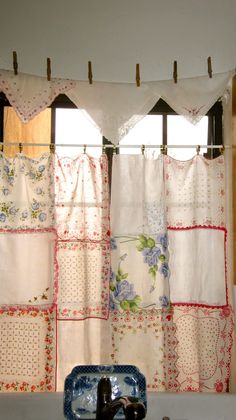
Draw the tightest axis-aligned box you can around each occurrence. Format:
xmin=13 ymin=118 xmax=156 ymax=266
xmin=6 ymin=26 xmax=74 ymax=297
xmin=0 ymin=149 xmax=233 ymax=392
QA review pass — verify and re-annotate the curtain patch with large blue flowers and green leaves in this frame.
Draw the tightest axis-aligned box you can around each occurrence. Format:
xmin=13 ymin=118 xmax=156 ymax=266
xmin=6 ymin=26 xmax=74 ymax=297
xmin=110 ymin=234 xmax=170 ymax=312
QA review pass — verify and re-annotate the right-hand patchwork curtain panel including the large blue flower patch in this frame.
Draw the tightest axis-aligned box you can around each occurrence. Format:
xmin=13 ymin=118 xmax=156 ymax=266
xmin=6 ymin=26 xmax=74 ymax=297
xmin=110 ymin=155 xmax=233 ymax=392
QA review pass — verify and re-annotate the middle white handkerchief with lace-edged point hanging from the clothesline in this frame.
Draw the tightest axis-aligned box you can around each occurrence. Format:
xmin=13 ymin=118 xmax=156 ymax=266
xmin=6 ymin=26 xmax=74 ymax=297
xmin=68 ymin=82 xmax=160 ymax=144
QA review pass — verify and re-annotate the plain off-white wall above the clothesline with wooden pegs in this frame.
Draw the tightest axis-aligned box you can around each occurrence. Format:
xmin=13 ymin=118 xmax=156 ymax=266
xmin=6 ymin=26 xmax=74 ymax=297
xmin=0 ymin=0 xmax=236 ymax=82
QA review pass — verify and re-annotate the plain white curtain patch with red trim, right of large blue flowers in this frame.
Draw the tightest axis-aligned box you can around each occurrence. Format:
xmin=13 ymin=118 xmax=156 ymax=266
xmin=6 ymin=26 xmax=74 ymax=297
xmin=168 ymin=228 xmax=227 ymax=306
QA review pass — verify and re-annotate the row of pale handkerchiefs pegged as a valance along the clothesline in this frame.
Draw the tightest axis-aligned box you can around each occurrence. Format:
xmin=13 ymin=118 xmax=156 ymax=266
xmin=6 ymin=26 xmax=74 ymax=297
xmin=0 ymin=70 xmax=234 ymax=144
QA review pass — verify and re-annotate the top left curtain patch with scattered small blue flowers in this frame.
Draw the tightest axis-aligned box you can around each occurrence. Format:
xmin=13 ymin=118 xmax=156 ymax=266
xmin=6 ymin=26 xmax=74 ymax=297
xmin=0 ymin=153 xmax=55 ymax=229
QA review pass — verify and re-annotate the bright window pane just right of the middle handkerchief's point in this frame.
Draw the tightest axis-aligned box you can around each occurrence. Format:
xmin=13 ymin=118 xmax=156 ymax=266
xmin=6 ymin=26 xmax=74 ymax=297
xmin=119 ymin=115 xmax=162 ymax=157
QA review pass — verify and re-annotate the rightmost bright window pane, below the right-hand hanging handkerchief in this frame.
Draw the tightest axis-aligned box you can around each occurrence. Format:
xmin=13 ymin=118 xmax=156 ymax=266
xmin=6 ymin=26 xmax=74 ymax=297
xmin=167 ymin=115 xmax=208 ymax=160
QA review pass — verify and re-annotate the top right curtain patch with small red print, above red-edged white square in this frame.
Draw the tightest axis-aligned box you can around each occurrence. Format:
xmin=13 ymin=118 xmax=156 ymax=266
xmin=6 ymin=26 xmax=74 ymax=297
xmin=165 ymin=155 xmax=225 ymax=228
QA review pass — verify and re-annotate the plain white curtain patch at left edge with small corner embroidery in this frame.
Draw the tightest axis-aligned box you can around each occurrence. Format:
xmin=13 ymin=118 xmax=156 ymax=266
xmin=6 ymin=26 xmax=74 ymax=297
xmin=0 ymin=231 xmax=57 ymax=305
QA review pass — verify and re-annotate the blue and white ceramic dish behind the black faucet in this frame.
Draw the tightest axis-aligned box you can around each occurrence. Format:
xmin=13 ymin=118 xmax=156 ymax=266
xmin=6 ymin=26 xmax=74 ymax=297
xmin=64 ymin=365 xmax=147 ymax=420
